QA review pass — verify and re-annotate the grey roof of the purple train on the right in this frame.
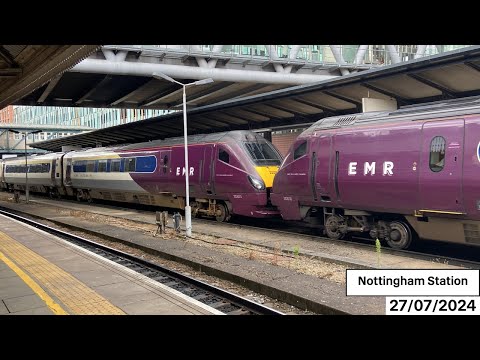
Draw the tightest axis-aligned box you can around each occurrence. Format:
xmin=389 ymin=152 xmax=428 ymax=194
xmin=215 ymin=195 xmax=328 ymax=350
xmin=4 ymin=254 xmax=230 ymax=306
xmin=302 ymin=96 xmax=480 ymax=135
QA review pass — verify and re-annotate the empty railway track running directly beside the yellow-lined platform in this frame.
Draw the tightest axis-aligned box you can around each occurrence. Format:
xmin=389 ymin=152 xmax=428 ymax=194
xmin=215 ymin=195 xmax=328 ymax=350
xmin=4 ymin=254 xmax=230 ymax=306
xmin=0 ymin=207 xmax=283 ymax=315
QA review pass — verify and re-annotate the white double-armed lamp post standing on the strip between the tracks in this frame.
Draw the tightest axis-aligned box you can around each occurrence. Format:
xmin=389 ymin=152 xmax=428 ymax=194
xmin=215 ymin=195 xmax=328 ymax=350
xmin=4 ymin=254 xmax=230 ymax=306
xmin=152 ymin=72 xmax=213 ymax=237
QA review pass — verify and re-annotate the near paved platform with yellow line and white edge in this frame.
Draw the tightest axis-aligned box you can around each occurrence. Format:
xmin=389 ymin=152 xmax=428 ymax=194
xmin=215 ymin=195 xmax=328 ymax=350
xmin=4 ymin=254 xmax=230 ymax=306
xmin=0 ymin=215 xmax=219 ymax=315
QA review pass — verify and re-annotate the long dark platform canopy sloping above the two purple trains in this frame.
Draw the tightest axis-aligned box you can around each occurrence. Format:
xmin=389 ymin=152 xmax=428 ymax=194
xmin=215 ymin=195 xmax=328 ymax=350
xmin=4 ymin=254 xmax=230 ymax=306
xmin=32 ymin=46 xmax=480 ymax=151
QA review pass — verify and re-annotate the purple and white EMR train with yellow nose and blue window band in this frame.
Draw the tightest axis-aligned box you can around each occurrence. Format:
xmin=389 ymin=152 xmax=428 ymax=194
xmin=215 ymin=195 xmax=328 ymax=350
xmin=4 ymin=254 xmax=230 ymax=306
xmin=0 ymin=131 xmax=282 ymax=221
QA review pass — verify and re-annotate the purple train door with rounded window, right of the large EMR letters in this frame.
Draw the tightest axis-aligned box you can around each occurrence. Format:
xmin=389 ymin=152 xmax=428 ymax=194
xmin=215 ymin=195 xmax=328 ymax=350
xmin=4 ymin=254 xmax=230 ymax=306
xmin=413 ymin=119 xmax=465 ymax=213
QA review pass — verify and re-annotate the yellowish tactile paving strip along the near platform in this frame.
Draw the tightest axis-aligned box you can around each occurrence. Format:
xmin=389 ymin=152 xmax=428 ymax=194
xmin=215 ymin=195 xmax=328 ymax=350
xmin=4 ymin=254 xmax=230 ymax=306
xmin=0 ymin=231 xmax=125 ymax=315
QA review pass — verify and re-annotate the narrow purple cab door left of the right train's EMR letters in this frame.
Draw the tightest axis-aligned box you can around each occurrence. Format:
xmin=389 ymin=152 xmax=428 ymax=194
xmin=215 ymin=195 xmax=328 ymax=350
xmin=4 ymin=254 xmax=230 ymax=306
xmin=310 ymin=136 xmax=332 ymax=201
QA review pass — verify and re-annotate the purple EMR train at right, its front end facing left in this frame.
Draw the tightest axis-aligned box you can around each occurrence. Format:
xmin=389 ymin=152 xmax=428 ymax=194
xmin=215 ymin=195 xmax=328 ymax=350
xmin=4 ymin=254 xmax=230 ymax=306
xmin=271 ymin=98 xmax=480 ymax=249
